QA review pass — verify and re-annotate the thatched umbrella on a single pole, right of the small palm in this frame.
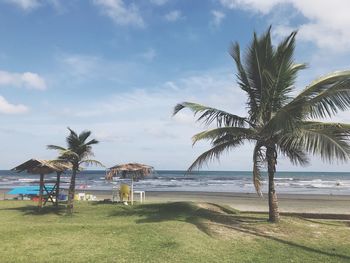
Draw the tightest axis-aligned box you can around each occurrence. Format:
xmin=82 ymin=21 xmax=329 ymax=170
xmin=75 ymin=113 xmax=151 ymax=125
xmin=106 ymin=163 xmax=154 ymax=204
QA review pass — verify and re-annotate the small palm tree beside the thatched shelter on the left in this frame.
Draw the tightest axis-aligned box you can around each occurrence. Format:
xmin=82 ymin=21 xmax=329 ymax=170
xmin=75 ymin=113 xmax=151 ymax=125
xmin=47 ymin=128 xmax=103 ymax=214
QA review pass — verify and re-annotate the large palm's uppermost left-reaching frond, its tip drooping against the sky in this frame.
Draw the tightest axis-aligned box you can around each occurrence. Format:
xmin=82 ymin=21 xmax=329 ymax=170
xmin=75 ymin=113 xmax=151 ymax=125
xmin=173 ymin=102 xmax=248 ymax=127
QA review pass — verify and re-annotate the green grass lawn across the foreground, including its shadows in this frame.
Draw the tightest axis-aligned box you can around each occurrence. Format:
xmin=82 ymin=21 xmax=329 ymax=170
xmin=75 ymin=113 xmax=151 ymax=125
xmin=0 ymin=201 xmax=350 ymax=263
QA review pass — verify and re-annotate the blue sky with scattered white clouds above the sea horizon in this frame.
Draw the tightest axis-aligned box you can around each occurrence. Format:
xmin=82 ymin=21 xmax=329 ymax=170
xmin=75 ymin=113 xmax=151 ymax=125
xmin=0 ymin=0 xmax=350 ymax=171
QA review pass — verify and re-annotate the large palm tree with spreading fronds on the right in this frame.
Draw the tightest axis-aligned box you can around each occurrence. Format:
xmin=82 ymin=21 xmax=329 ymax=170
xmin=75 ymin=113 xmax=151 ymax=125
xmin=174 ymin=27 xmax=350 ymax=222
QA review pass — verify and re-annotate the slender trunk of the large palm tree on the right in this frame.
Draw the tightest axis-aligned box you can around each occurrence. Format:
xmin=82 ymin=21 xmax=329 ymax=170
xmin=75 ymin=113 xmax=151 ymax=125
xmin=266 ymin=146 xmax=280 ymax=223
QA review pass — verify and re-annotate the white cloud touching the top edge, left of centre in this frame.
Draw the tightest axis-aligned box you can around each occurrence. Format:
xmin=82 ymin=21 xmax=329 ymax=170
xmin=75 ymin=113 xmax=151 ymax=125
xmin=93 ymin=0 xmax=145 ymax=27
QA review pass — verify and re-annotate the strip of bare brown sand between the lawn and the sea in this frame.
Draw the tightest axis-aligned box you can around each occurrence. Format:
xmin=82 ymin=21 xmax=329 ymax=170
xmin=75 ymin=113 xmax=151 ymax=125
xmin=0 ymin=189 xmax=350 ymax=217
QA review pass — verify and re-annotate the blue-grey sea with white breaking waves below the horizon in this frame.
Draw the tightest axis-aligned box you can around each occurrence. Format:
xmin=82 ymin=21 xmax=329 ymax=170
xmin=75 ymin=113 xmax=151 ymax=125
xmin=0 ymin=170 xmax=350 ymax=195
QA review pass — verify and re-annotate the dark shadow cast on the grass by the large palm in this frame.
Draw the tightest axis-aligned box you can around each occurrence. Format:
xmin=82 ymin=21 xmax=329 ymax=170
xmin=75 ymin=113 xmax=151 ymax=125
xmin=110 ymin=202 xmax=350 ymax=262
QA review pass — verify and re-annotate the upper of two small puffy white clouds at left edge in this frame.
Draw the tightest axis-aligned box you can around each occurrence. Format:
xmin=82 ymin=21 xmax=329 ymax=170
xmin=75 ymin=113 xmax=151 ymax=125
xmin=0 ymin=71 xmax=46 ymax=90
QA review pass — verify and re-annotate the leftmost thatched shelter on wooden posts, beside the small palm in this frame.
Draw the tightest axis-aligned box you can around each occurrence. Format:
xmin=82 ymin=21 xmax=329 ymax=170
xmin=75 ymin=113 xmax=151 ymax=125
xmin=12 ymin=159 xmax=70 ymax=208
